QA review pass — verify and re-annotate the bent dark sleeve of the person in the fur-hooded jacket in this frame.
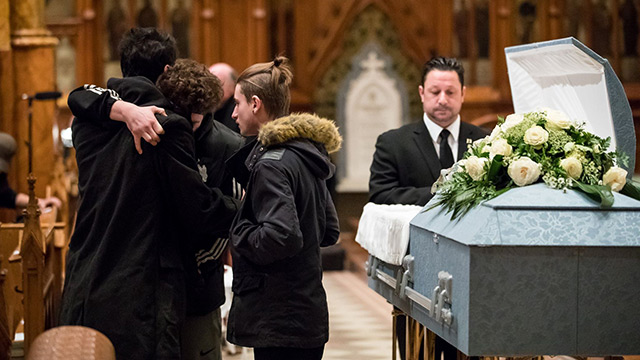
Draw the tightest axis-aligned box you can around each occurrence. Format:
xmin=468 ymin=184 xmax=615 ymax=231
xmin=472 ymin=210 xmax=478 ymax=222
xmin=231 ymin=161 xmax=303 ymax=265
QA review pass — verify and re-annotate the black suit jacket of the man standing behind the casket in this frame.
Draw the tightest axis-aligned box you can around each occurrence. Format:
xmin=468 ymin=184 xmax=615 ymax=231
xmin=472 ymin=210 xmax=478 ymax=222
xmin=369 ymin=120 xmax=486 ymax=206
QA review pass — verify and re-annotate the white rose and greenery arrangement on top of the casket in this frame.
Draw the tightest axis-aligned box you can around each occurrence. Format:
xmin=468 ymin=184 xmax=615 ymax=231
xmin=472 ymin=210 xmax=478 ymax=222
xmin=429 ymin=109 xmax=640 ymax=219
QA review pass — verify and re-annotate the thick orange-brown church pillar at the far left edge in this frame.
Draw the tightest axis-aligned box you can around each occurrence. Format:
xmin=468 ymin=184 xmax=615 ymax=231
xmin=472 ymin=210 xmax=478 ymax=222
xmin=9 ymin=0 xmax=58 ymax=196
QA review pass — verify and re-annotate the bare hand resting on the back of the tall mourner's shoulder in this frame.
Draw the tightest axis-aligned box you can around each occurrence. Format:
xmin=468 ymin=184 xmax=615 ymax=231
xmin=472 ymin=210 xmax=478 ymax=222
xmin=110 ymin=100 xmax=167 ymax=154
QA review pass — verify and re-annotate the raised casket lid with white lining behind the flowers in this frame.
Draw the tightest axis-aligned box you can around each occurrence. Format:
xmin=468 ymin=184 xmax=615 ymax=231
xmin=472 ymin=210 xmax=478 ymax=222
xmin=505 ymin=37 xmax=636 ymax=172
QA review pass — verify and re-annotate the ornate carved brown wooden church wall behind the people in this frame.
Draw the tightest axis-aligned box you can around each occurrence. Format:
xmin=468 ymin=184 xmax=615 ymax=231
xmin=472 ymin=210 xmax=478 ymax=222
xmin=0 ymin=0 xmax=640 ymax=228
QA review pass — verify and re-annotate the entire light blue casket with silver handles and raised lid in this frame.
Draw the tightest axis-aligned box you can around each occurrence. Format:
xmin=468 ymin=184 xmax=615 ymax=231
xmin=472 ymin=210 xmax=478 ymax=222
xmin=367 ymin=38 xmax=640 ymax=356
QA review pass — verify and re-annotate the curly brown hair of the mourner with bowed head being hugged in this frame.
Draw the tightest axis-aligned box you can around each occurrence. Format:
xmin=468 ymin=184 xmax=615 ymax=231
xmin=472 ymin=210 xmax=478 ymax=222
xmin=156 ymin=59 xmax=222 ymax=116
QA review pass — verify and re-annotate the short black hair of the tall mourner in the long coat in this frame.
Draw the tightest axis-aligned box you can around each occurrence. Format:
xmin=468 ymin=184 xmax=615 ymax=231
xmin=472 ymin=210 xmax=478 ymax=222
xmin=119 ymin=27 xmax=178 ymax=83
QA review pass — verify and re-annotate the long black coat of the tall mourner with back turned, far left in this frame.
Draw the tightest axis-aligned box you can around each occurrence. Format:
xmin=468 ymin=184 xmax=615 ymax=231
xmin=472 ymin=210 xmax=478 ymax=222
xmin=60 ymin=77 xmax=236 ymax=359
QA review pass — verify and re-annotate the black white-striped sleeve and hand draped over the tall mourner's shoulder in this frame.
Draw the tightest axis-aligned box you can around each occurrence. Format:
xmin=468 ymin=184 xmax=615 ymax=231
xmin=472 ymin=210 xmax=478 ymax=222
xmin=67 ymin=85 xmax=166 ymax=154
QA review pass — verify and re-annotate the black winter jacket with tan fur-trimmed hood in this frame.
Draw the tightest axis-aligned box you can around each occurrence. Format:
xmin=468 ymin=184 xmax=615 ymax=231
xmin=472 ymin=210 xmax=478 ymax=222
xmin=227 ymin=114 xmax=342 ymax=348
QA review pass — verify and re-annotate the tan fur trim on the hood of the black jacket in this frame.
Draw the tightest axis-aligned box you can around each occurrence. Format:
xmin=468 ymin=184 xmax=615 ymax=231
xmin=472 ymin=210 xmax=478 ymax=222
xmin=258 ymin=113 xmax=342 ymax=153
